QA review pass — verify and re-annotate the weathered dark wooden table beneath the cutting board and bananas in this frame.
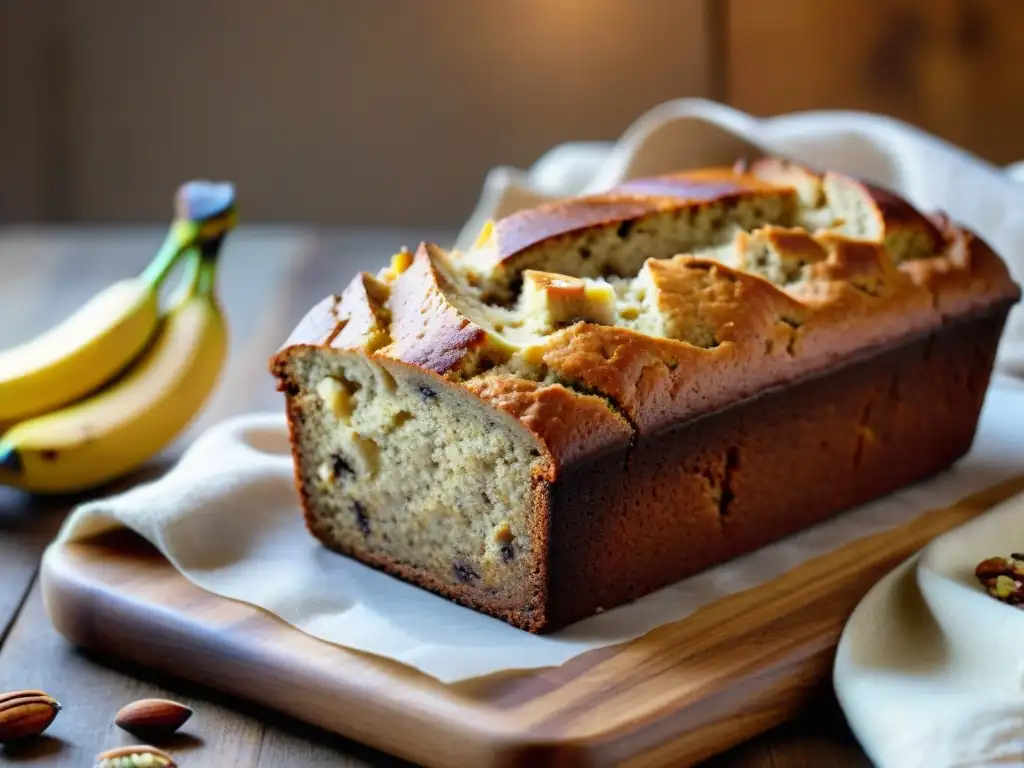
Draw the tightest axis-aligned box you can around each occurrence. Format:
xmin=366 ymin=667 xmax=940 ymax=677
xmin=0 ymin=227 xmax=870 ymax=768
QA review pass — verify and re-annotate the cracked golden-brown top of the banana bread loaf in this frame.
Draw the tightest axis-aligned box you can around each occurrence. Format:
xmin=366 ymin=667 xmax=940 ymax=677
xmin=273 ymin=158 xmax=1020 ymax=467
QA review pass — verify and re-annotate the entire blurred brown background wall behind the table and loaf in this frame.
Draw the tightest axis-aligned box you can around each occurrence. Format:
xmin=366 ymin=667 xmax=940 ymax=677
xmin=0 ymin=0 xmax=1024 ymax=227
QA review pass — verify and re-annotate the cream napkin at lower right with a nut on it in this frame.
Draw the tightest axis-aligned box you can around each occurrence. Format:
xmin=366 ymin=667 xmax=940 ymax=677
xmin=834 ymin=462 xmax=1024 ymax=768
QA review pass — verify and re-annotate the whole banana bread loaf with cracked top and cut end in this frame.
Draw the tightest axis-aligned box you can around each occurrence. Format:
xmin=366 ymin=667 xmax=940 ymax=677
xmin=271 ymin=158 xmax=1020 ymax=632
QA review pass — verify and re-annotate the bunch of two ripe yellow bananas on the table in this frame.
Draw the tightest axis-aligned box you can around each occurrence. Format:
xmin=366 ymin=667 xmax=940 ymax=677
xmin=0 ymin=181 xmax=237 ymax=494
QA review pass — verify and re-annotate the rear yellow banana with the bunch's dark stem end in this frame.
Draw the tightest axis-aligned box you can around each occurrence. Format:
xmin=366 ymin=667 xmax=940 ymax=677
xmin=0 ymin=181 xmax=234 ymax=423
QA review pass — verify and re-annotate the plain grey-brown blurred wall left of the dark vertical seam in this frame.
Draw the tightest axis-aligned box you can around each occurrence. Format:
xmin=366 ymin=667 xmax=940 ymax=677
xmin=0 ymin=0 xmax=708 ymax=226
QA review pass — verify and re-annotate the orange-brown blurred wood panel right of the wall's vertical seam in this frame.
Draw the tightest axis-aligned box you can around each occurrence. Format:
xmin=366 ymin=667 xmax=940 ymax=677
xmin=724 ymin=0 xmax=1024 ymax=164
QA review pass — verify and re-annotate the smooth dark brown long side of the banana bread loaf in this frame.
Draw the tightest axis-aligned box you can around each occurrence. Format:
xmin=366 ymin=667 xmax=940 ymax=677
xmin=547 ymin=311 xmax=1002 ymax=629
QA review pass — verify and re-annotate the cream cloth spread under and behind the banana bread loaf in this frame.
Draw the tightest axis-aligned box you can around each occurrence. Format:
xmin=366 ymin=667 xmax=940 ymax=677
xmin=51 ymin=100 xmax=1024 ymax=682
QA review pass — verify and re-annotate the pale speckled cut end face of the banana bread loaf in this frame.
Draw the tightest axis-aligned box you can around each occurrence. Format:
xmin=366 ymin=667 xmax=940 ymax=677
xmin=275 ymin=345 xmax=550 ymax=631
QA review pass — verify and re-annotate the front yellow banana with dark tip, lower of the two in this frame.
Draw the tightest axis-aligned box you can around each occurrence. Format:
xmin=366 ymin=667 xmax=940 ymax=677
xmin=0 ymin=249 xmax=227 ymax=494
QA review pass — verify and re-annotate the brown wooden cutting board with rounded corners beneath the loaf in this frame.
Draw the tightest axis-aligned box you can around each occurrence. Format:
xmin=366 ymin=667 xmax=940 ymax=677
xmin=42 ymin=476 xmax=1024 ymax=768
